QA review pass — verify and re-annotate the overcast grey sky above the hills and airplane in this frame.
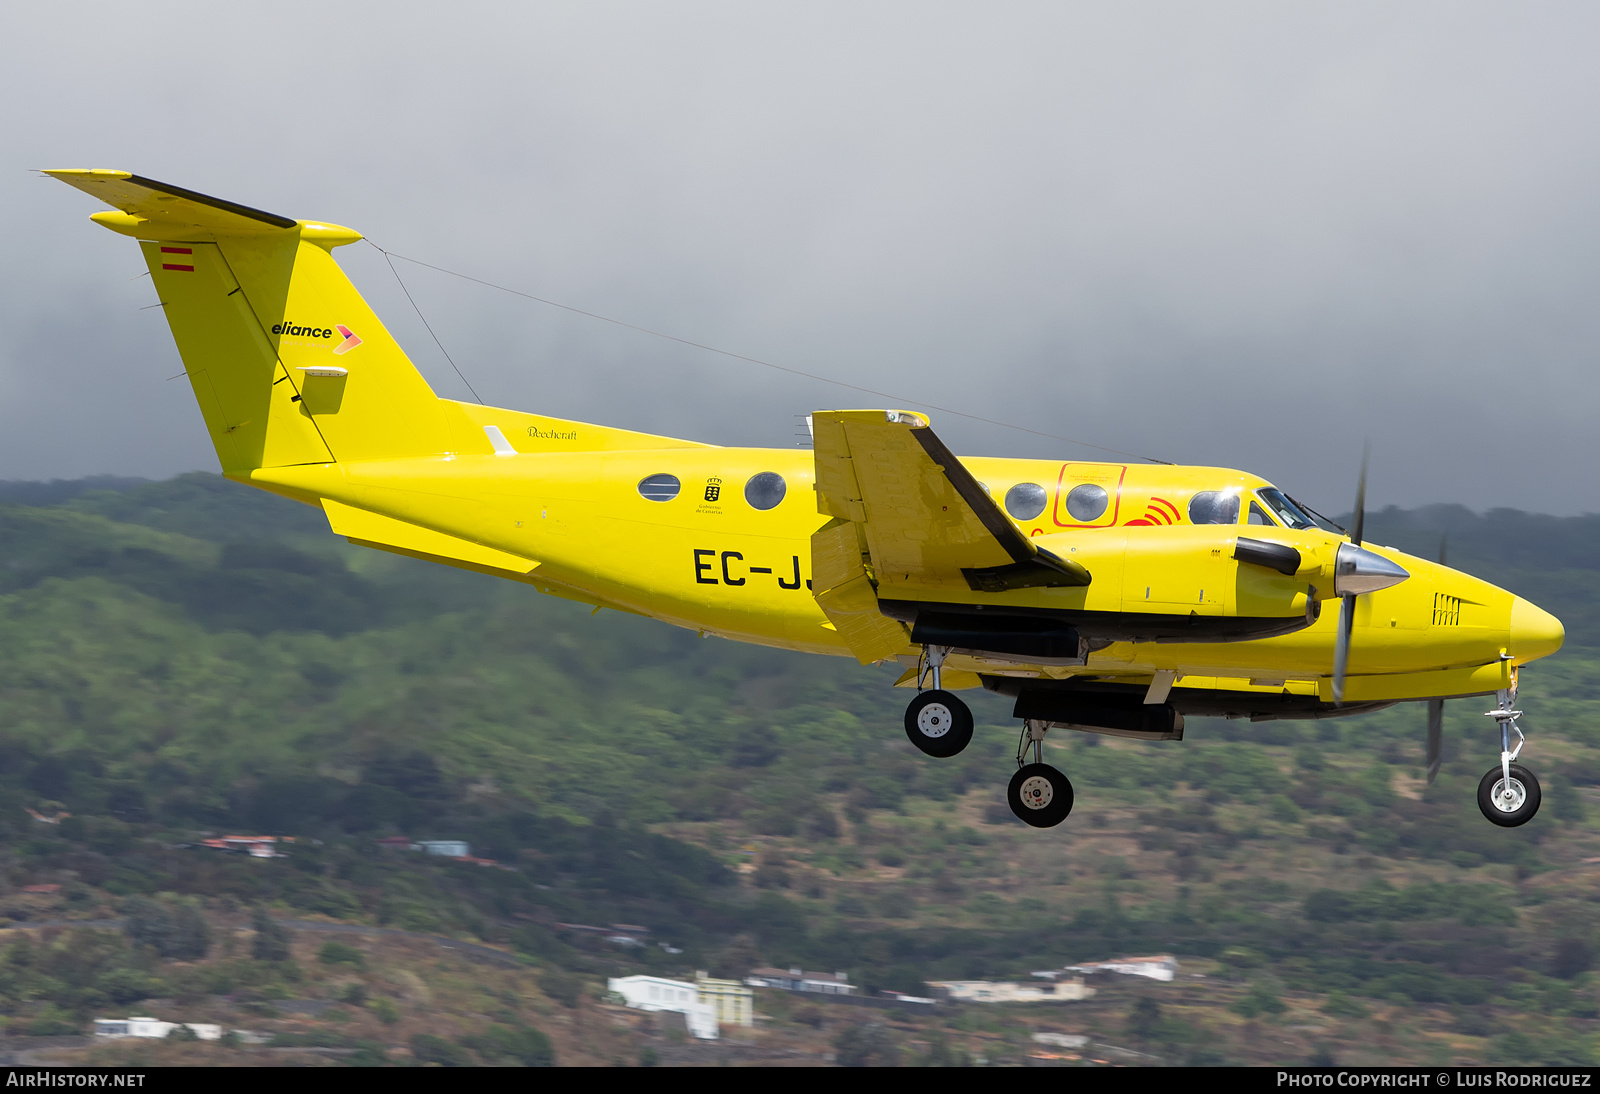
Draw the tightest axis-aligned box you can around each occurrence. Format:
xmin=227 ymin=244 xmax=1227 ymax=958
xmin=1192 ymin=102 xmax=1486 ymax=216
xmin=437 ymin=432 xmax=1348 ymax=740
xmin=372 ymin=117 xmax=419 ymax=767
xmin=0 ymin=0 xmax=1600 ymax=513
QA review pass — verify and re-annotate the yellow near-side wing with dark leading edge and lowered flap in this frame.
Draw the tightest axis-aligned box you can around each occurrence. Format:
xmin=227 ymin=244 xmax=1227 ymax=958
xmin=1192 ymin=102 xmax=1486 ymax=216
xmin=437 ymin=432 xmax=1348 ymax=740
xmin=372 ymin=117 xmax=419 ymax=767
xmin=811 ymin=411 xmax=1090 ymax=662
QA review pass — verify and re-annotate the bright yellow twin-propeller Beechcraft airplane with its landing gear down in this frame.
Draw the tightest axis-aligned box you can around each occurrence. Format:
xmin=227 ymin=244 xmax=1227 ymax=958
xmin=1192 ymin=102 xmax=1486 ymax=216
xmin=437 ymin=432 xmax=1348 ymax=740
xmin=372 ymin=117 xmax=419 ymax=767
xmin=45 ymin=170 xmax=1563 ymax=827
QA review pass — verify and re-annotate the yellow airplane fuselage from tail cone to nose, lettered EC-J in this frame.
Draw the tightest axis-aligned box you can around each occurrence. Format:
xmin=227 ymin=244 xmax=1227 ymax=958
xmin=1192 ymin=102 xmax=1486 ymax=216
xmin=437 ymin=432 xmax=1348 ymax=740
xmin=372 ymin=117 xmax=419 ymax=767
xmin=250 ymin=406 xmax=1562 ymax=699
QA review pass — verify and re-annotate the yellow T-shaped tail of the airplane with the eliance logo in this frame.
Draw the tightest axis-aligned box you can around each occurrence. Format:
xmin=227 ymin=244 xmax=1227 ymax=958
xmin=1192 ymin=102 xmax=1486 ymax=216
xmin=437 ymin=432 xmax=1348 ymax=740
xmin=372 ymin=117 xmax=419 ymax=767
xmin=45 ymin=171 xmax=457 ymax=473
